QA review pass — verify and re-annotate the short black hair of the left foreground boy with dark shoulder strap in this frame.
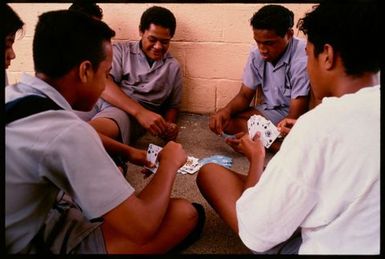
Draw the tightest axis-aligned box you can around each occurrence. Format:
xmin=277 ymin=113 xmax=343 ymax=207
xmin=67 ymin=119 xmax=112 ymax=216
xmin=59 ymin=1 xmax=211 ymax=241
xmin=33 ymin=10 xmax=115 ymax=78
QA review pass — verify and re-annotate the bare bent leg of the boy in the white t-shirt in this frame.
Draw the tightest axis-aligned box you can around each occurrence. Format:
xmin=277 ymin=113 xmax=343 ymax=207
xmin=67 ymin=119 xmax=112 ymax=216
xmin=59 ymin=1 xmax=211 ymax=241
xmin=197 ymin=163 xmax=245 ymax=234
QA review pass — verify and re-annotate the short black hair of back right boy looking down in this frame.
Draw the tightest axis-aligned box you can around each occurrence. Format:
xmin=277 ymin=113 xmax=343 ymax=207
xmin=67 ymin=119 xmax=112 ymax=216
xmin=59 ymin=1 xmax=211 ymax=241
xmin=250 ymin=5 xmax=294 ymax=37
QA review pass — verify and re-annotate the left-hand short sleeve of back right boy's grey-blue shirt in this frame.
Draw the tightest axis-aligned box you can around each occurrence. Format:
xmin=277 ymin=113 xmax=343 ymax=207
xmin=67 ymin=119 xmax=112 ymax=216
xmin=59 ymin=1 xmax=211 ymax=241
xmin=243 ymin=48 xmax=262 ymax=90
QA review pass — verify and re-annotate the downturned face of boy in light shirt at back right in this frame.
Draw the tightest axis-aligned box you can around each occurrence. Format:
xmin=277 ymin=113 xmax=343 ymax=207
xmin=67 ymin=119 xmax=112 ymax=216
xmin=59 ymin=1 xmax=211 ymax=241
xmin=253 ymin=29 xmax=292 ymax=63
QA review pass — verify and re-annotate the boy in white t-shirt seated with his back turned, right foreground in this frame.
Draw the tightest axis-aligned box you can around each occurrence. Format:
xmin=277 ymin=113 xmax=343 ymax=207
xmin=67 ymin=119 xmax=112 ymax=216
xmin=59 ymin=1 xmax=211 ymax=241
xmin=197 ymin=1 xmax=381 ymax=254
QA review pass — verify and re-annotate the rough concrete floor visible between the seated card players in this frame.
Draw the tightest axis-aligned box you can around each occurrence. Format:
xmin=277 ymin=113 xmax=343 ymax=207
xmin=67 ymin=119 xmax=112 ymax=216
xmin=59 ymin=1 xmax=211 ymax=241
xmin=127 ymin=113 xmax=271 ymax=254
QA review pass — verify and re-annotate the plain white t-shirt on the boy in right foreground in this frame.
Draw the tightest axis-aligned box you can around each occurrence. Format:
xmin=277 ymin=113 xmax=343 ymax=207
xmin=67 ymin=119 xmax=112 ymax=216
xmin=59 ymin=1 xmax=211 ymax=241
xmin=236 ymin=85 xmax=380 ymax=254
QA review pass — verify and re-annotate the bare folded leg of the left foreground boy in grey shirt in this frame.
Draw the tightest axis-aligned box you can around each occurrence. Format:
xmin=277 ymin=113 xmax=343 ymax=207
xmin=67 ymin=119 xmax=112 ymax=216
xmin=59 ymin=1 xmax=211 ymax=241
xmin=102 ymin=199 xmax=198 ymax=254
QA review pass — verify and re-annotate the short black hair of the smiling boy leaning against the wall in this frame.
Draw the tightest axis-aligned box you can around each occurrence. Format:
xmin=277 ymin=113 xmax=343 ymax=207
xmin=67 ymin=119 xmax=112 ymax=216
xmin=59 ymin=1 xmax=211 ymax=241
xmin=139 ymin=6 xmax=176 ymax=37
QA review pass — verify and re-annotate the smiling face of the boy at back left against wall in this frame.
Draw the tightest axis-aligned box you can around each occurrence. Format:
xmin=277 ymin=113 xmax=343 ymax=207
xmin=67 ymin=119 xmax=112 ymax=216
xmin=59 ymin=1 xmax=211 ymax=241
xmin=140 ymin=23 xmax=171 ymax=60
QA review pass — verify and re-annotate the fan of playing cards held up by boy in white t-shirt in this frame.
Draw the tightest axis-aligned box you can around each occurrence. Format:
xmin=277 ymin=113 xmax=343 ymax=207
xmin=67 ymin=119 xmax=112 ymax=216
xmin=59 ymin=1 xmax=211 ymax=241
xmin=247 ymin=115 xmax=280 ymax=148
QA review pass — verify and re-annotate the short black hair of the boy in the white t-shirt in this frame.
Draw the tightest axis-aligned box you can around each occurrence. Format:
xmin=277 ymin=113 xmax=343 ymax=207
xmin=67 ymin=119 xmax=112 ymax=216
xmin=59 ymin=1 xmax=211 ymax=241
xmin=297 ymin=0 xmax=383 ymax=75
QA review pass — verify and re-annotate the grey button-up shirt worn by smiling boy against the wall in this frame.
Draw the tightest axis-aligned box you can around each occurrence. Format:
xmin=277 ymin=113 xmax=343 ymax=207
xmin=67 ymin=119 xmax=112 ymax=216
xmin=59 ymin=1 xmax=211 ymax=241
xmin=110 ymin=41 xmax=182 ymax=111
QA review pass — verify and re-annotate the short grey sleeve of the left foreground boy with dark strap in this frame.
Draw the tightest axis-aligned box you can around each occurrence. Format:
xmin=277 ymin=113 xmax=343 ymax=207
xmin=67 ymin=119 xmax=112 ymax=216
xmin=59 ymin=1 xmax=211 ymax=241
xmin=42 ymin=123 xmax=134 ymax=219
